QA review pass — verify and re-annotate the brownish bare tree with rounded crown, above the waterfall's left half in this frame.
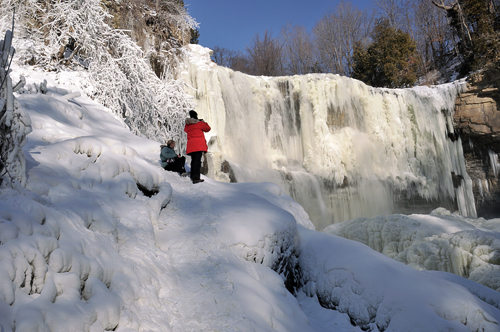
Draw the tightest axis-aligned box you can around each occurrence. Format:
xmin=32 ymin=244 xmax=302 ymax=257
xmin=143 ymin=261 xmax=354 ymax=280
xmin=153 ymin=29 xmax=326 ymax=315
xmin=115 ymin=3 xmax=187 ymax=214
xmin=246 ymin=30 xmax=283 ymax=76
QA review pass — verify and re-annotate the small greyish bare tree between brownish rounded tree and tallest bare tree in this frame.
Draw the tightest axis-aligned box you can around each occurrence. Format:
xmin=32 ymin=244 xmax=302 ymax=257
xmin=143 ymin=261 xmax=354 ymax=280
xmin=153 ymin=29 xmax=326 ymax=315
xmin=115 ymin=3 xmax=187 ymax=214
xmin=281 ymin=24 xmax=315 ymax=75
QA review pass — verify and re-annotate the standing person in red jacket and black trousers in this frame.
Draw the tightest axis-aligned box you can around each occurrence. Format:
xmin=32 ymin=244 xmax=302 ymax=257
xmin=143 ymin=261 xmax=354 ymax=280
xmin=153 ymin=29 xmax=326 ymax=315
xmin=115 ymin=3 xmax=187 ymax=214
xmin=184 ymin=111 xmax=211 ymax=183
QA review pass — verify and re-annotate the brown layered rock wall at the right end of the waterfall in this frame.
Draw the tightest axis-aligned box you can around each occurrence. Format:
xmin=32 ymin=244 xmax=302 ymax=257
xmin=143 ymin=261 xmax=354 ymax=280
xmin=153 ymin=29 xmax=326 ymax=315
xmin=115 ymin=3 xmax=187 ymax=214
xmin=454 ymin=70 xmax=500 ymax=218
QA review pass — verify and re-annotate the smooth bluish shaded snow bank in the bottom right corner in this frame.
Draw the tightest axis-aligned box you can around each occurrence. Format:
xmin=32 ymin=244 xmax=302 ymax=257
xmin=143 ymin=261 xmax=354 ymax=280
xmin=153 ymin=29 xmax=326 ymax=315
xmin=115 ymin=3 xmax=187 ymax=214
xmin=299 ymin=229 xmax=500 ymax=332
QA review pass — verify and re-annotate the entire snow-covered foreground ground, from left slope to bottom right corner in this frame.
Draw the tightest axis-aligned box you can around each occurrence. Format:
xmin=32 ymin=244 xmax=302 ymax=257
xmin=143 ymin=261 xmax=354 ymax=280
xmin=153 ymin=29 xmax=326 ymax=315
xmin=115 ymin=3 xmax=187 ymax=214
xmin=0 ymin=68 xmax=500 ymax=332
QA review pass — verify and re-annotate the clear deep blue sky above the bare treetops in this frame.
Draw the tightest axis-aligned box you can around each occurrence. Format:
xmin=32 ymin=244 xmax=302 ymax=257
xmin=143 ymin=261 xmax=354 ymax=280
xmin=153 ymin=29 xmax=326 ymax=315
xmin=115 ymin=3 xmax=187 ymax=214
xmin=184 ymin=0 xmax=372 ymax=51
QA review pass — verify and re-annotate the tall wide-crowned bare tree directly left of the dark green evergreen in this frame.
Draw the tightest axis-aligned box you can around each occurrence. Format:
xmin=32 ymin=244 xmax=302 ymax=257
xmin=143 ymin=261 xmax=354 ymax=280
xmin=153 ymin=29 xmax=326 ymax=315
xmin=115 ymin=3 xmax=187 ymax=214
xmin=313 ymin=1 xmax=373 ymax=76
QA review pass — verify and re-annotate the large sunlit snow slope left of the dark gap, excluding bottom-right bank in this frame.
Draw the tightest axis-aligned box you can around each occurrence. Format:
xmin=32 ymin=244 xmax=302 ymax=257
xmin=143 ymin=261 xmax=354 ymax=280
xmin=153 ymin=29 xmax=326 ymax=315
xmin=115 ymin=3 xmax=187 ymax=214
xmin=0 ymin=67 xmax=313 ymax=331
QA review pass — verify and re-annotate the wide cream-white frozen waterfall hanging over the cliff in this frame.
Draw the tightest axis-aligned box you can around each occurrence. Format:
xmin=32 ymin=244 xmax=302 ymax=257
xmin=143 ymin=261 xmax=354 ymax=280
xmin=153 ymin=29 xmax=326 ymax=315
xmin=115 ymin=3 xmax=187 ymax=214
xmin=183 ymin=45 xmax=476 ymax=229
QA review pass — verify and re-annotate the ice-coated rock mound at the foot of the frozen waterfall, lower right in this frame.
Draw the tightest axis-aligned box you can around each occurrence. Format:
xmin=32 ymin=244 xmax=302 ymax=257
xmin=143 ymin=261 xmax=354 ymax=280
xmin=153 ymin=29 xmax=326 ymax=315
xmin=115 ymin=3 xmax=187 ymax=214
xmin=324 ymin=213 xmax=500 ymax=291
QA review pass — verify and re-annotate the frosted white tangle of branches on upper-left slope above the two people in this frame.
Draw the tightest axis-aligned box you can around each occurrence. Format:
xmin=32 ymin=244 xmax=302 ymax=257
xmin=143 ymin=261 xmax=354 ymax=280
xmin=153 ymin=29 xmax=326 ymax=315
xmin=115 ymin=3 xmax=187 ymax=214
xmin=0 ymin=0 xmax=196 ymax=145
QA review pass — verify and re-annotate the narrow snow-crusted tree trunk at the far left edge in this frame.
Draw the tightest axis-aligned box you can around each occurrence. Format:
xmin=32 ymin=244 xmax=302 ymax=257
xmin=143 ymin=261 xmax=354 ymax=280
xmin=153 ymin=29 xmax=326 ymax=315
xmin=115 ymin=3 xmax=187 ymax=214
xmin=0 ymin=26 xmax=31 ymax=186
